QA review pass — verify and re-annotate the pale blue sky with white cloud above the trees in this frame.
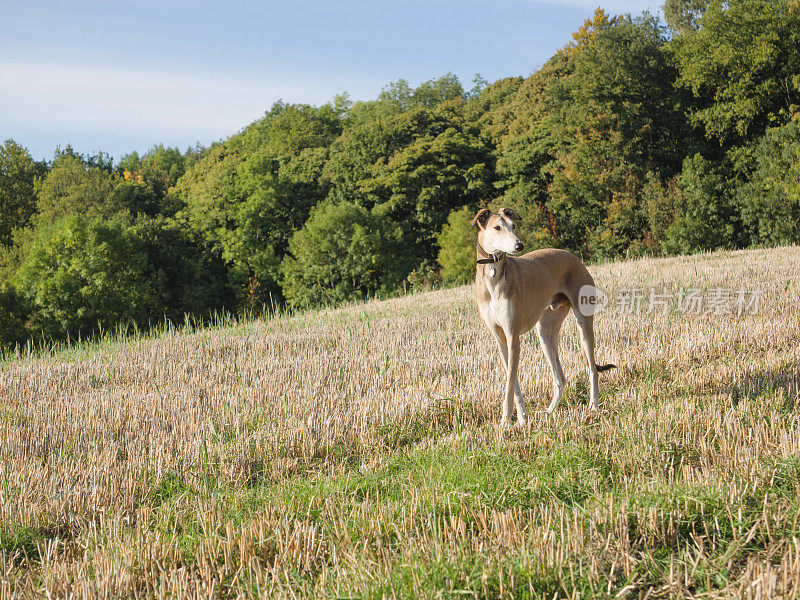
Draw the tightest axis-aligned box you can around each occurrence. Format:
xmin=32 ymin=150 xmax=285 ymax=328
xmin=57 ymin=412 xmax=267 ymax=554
xmin=0 ymin=0 xmax=661 ymax=160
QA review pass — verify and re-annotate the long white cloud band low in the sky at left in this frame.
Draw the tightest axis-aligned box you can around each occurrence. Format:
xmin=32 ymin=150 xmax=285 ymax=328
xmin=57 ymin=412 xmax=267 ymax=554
xmin=0 ymin=59 xmax=380 ymax=139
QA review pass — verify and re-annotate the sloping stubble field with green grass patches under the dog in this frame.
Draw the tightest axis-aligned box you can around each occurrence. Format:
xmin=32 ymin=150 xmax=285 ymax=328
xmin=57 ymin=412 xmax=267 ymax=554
xmin=0 ymin=247 xmax=800 ymax=599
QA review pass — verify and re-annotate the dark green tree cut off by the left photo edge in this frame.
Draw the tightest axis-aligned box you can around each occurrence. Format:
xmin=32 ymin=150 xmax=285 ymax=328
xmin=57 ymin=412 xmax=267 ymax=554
xmin=0 ymin=140 xmax=43 ymax=246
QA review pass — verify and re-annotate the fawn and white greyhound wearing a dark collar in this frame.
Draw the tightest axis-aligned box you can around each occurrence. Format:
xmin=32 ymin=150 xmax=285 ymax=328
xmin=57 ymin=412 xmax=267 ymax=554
xmin=472 ymin=208 xmax=614 ymax=425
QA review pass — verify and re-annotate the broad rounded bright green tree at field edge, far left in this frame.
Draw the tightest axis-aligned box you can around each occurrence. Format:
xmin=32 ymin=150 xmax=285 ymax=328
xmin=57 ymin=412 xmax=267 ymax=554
xmin=13 ymin=215 xmax=158 ymax=338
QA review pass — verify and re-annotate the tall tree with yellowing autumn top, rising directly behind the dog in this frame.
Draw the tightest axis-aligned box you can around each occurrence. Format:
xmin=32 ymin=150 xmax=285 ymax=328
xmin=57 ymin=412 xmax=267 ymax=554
xmin=498 ymin=10 xmax=687 ymax=257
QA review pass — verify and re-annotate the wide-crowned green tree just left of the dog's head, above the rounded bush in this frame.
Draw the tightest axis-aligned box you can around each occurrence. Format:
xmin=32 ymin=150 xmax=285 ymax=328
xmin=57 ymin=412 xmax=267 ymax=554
xmin=325 ymin=105 xmax=494 ymax=261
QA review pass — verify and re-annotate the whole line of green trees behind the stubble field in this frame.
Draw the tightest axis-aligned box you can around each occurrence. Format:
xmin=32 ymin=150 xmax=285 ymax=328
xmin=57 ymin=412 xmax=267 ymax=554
xmin=0 ymin=0 xmax=800 ymax=345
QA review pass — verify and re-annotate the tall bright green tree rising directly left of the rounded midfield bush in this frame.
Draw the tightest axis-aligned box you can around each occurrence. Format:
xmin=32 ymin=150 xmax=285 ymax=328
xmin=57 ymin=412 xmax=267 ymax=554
xmin=174 ymin=103 xmax=342 ymax=308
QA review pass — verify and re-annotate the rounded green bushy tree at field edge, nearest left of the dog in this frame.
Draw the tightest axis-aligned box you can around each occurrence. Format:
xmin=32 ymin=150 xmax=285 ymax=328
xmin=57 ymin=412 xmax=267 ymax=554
xmin=282 ymin=202 xmax=412 ymax=306
